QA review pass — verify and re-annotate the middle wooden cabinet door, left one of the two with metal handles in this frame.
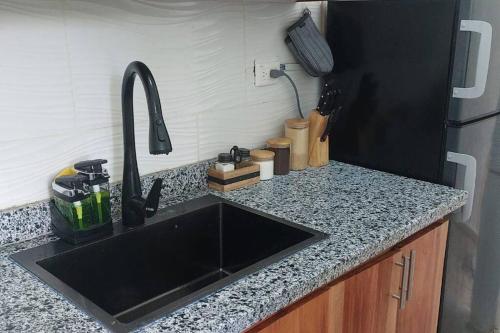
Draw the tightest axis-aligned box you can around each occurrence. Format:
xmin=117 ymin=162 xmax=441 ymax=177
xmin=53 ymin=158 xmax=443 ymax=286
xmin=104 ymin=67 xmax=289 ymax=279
xmin=329 ymin=251 xmax=402 ymax=333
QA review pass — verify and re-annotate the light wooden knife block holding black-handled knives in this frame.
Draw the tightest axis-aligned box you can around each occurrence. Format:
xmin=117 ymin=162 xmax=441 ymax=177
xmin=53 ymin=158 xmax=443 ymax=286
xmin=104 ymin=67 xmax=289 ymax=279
xmin=309 ymin=110 xmax=329 ymax=167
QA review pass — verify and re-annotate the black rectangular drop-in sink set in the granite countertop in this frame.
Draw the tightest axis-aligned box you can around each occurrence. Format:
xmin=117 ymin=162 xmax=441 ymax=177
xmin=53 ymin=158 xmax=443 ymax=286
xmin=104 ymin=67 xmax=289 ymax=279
xmin=12 ymin=195 xmax=326 ymax=332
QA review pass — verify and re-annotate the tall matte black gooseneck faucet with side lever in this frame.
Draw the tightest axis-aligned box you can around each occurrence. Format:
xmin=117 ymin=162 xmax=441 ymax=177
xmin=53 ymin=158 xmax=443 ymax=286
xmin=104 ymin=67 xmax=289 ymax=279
xmin=122 ymin=61 xmax=172 ymax=226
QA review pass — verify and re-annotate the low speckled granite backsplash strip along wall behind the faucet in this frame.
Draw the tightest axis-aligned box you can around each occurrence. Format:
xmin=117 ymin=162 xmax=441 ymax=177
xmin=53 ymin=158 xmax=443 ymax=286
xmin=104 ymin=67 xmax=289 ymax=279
xmin=0 ymin=161 xmax=211 ymax=246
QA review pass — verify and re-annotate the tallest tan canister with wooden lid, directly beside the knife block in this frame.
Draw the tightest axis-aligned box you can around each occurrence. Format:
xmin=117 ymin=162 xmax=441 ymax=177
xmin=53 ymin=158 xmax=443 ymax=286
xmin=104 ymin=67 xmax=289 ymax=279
xmin=285 ymin=119 xmax=309 ymax=170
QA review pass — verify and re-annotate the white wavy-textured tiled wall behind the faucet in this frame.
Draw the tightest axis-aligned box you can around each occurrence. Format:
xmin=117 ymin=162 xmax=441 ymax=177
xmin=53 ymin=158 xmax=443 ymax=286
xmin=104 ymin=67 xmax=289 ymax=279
xmin=0 ymin=0 xmax=320 ymax=209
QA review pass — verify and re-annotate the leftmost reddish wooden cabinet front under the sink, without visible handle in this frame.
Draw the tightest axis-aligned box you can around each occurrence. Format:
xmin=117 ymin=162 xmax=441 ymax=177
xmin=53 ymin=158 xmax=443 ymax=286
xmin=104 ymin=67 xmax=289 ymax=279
xmin=254 ymin=289 xmax=333 ymax=333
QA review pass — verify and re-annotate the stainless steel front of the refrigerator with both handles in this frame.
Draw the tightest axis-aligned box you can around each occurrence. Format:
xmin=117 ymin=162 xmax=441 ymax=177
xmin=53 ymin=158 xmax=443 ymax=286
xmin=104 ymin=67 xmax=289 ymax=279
xmin=440 ymin=0 xmax=500 ymax=333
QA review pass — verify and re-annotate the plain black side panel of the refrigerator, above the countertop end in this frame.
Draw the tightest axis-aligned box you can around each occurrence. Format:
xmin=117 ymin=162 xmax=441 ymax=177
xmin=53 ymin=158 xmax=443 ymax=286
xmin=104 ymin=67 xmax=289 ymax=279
xmin=327 ymin=0 xmax=455 ymax=182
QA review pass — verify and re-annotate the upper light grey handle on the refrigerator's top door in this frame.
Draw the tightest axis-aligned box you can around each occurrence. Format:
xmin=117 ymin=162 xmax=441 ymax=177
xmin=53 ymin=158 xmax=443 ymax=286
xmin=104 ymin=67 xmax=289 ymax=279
xmin=453 ymin=20 xmax=493 ymax=98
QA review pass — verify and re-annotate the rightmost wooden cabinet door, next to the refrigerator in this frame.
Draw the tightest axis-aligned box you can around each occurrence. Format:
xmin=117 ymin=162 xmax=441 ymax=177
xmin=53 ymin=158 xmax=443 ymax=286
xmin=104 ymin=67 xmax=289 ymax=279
xmin=397 ymin=221 xmax=448 ymax=333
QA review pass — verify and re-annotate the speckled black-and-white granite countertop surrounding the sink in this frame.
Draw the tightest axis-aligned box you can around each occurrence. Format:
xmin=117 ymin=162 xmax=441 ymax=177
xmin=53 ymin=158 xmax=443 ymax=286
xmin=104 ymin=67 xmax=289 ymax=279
xmin=0 ymin=162 xmax=467 ymax=332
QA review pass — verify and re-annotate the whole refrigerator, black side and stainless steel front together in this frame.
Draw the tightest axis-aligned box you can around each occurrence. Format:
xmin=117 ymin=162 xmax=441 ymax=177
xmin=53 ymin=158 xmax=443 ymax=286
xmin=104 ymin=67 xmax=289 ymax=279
xmin=327 ymin=0 xmax=500 ymax=333
